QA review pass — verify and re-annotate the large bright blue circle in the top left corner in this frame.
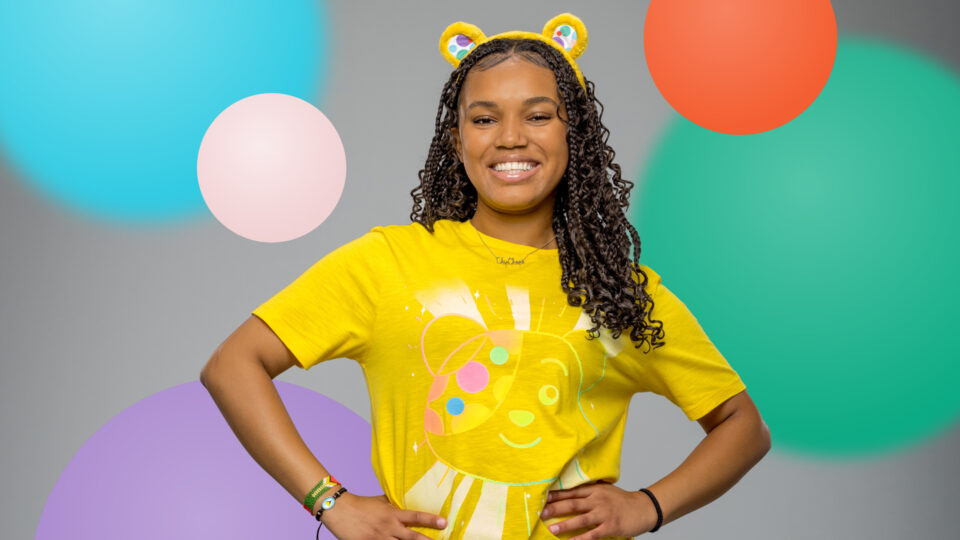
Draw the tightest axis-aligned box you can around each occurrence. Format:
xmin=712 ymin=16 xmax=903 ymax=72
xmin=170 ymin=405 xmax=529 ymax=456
xmin=0 ymin=0 xmax=334 ymax=225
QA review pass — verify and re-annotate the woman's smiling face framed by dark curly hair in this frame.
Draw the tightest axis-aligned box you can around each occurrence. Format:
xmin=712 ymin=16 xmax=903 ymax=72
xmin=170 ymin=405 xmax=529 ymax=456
xmin=451 ymin=53 xmax=569 ymax=214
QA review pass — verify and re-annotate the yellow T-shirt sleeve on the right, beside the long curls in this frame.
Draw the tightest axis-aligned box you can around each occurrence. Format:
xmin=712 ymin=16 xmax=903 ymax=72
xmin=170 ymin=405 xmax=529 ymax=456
xmin=636 ymin=272 xmax=746 ymax=420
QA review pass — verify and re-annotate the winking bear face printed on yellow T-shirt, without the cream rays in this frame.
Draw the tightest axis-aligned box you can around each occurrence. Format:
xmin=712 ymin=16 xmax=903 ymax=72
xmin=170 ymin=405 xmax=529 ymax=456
xmin=421 ymin=315 xmax=596 ymax=484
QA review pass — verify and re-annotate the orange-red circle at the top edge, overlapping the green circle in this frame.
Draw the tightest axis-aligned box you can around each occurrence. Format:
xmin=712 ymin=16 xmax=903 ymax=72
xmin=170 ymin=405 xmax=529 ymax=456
xmin=643 ymin=0 xmax=837 ymax=134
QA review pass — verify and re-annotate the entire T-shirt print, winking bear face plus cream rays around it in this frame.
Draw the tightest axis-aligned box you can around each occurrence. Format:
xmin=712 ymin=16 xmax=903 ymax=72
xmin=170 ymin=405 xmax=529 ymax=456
xmin=404 ymin=280 xmax=620 ymax=538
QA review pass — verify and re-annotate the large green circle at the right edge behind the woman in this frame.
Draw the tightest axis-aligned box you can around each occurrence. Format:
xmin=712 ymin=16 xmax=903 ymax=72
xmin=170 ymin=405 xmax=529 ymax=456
xmin=631 ymin=38 xmax=960 ymax=457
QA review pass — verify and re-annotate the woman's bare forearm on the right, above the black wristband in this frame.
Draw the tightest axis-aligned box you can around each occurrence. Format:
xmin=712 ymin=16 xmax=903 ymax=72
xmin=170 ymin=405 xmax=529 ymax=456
xmin=640 ymin=414 xmax=770 ymax=524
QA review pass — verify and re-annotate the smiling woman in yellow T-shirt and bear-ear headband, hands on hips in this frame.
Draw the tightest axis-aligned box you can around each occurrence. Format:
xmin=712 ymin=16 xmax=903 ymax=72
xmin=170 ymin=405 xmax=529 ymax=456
xmin=201 ymin=14 xmax=770 ymax=539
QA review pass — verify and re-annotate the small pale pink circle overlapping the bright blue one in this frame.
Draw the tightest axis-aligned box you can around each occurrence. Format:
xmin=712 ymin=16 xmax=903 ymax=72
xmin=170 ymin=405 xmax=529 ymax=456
xmin=197 ymin=94 xmax=347 ymax=242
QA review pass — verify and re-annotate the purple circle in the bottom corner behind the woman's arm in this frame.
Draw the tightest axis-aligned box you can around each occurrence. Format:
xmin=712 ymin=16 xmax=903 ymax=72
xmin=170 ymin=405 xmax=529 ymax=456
xmin=34 ymin=381 xmax=383 ymax=540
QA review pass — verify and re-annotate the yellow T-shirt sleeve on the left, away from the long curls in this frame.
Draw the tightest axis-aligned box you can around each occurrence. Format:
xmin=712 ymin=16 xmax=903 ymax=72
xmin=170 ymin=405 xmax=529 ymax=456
xmin=252 ymin=227 xmax=387 ymax=369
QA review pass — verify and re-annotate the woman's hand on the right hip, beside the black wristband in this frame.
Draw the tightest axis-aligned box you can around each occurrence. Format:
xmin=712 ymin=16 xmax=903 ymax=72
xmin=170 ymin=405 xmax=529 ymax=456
xmin=540 ymin=481 xmax=657 ymax=540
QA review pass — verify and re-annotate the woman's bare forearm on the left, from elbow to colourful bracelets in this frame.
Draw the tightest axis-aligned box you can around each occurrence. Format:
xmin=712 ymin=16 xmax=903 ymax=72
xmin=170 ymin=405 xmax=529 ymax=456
xmin=201 ymin=344 xmax=329 ymax=508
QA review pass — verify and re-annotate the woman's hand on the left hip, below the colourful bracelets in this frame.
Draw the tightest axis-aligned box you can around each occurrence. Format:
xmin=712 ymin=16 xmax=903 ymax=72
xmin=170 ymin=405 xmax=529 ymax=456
xmin=314 ymin=491 xmax=447 ymax=540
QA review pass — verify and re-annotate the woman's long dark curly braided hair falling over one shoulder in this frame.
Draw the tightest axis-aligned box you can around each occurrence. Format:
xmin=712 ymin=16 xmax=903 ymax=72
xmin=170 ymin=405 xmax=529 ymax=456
xmin=410 ymin=39 xmax=665 ymax=352
